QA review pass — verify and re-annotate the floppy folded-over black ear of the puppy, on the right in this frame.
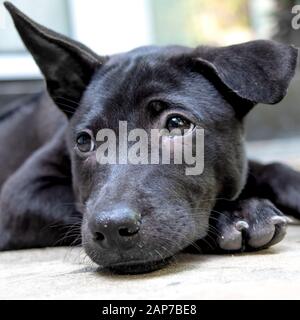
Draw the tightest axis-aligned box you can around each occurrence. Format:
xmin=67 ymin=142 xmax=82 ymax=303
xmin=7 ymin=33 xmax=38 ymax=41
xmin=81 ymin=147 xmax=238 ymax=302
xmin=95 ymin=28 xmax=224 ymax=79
xmin=193 ymin=40 xmax=298 ymax=115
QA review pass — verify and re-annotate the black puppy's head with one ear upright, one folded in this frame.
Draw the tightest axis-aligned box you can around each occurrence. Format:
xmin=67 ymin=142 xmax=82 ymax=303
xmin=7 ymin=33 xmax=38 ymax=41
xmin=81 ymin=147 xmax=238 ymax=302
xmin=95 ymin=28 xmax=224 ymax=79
xmin=6 ymin=4 xmax=297 ymax=272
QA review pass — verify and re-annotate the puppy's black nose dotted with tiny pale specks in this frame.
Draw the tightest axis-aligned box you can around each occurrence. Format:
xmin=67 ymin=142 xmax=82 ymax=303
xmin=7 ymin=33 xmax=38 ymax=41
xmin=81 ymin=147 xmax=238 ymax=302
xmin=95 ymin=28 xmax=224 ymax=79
xmin=89 ymin=208 xmax=141 ymax=249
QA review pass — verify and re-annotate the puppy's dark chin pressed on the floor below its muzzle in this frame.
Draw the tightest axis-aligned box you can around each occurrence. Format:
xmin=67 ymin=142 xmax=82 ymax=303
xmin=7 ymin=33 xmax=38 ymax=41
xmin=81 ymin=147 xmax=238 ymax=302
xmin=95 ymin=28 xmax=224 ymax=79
xmin=105 ymin=257 xmax=172 ymax=275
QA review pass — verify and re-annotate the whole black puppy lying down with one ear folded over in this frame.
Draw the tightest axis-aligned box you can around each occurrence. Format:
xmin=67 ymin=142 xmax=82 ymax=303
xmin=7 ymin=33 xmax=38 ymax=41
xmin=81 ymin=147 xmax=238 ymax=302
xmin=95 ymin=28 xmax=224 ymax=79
xmin=0 ymin=3 xmax=300 ymax=273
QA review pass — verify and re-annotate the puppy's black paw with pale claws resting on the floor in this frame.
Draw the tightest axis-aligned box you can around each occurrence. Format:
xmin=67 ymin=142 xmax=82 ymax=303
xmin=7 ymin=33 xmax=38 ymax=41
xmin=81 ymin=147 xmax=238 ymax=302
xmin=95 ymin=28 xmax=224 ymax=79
xmin=215 ymin=199 xmax=288 ymax=252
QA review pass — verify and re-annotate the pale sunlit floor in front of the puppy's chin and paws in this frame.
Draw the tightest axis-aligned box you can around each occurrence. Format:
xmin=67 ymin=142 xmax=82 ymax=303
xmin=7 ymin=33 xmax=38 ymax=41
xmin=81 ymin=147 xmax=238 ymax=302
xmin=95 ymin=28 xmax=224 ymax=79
xmin=0 ymin=225 xmax=300 ymax=300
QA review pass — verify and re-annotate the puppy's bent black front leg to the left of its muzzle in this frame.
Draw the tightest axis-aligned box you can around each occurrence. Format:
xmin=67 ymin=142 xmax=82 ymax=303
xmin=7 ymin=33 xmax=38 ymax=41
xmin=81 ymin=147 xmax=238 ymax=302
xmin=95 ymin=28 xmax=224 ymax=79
xmin=0 ymin=132 xmax=81 ymax=250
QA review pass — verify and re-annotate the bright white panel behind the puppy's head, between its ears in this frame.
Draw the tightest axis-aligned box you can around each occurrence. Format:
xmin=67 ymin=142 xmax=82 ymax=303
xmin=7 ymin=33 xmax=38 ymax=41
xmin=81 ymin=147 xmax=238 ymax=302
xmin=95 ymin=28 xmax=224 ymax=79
xmin=70 ymin=0 xmax=152 ymax=54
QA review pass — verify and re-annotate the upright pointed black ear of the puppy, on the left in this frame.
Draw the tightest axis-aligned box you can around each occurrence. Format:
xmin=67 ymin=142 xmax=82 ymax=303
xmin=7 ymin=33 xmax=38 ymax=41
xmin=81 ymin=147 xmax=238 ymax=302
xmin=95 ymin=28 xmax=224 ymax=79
xmin=5 ymin=2 xmax=106 ymax=116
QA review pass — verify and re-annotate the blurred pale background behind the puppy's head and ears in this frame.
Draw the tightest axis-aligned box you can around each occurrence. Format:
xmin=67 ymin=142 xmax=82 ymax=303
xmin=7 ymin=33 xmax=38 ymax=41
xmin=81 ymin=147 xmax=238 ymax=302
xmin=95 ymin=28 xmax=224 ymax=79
xmin=0 ymin=0 xmax=300 ymax=165
